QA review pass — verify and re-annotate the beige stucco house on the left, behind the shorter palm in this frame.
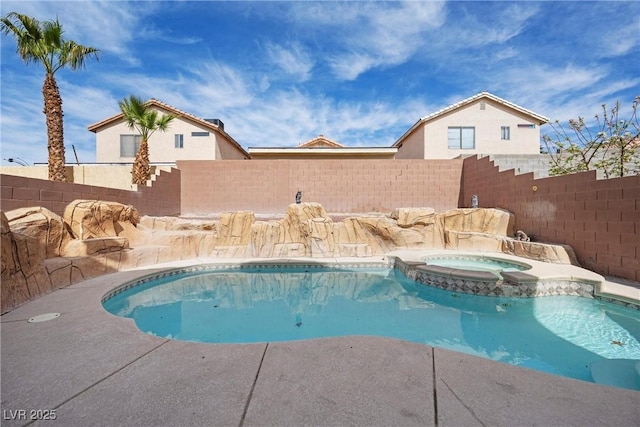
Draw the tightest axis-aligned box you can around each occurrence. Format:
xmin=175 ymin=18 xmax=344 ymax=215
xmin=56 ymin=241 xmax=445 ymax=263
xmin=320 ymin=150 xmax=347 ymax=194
xmin=88 ymin=98 xmax=251 ymax=163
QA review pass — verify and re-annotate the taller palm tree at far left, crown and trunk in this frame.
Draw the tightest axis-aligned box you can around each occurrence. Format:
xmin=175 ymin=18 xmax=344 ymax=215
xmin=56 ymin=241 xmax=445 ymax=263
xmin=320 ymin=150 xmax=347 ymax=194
xmin=0 ymin=12 xmax=99 ymax=181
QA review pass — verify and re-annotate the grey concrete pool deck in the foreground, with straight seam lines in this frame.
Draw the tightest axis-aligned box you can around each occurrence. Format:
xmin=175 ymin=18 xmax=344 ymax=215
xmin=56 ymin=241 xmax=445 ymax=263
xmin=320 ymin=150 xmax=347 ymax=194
xmin=1 ymin=258 xmax=640 ymax=426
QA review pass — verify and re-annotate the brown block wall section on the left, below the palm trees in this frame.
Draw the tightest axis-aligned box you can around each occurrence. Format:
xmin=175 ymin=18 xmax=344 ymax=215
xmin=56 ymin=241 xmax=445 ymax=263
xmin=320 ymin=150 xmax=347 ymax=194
xmin=0 ymin=169 xmax=181 ymax=216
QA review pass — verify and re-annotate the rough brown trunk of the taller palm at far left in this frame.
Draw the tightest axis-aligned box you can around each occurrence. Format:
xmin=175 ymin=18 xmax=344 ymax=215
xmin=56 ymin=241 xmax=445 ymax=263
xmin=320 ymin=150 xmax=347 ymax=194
xmin=42 ymin=73 xmax=67 ymax=182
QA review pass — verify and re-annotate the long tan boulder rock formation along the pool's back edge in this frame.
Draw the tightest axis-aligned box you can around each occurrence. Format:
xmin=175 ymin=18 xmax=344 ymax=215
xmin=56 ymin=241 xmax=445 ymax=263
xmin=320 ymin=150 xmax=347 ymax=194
xmin=1 ymin=200 xmax=577 ymax=313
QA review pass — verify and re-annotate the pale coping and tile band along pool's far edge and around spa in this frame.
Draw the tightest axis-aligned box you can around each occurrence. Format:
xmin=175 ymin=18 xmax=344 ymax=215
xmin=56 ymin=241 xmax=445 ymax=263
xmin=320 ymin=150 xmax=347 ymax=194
xmin=102 ymin=250 xmax=640 ymax=310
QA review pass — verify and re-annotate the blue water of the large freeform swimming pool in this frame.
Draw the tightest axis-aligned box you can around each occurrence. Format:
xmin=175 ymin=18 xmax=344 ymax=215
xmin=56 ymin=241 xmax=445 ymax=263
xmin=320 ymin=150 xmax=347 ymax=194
xmin=103 ymin=267 xmax=640 ymax=390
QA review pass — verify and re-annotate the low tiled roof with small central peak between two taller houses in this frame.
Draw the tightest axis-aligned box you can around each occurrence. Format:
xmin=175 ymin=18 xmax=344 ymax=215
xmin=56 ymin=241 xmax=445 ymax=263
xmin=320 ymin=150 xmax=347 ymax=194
xmin=249 ymin=135 xmax=398 ymax=160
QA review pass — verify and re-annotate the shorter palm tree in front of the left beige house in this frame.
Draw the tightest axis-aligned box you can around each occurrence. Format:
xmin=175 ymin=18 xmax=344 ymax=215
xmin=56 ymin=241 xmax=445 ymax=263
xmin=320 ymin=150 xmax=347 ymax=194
xmin=118 ymin=95 xmax=175 ymax=185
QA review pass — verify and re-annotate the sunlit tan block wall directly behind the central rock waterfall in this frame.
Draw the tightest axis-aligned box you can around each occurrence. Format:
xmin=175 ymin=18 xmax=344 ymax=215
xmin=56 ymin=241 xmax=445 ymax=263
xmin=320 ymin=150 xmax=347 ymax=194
xmin=178 ymin=159 xmax=462 ymax=216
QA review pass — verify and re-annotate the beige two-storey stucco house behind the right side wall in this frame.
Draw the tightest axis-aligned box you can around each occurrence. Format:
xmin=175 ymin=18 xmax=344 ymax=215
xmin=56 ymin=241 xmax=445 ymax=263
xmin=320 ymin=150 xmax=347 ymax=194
xmin=393 ymin=92 xmax=549 ymax=159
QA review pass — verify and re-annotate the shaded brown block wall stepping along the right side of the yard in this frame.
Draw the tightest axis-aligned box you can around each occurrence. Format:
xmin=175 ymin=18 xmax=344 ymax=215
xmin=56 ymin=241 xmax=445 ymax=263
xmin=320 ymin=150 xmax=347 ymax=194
xmin=460 ymin=157 xmax=640 ymax=281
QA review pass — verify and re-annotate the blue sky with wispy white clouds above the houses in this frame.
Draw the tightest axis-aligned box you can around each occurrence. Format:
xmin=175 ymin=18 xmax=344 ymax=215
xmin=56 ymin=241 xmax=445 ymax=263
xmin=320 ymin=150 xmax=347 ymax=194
xmin=0 ymin=0 xmax=640 ymax=165
